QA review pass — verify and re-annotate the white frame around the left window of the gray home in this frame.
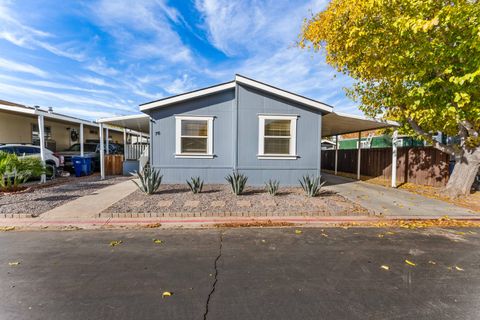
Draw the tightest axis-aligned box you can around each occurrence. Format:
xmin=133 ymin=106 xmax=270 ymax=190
xmin=175 ymin=116 xmax=215 ymax=159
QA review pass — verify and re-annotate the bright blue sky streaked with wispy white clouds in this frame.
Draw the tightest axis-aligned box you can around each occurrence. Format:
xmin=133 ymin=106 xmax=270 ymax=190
xmin=0 ymin=0 xmax=360 ymax=120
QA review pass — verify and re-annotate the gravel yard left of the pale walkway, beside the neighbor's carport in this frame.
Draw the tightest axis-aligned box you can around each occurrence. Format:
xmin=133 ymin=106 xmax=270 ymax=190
xmin=0 ymin=174 xmax=131 ymax=217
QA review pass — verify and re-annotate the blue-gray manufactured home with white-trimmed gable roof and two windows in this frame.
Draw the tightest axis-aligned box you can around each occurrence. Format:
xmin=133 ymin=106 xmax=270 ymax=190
xmin=140 ymin=76 xmax=332 ymax=185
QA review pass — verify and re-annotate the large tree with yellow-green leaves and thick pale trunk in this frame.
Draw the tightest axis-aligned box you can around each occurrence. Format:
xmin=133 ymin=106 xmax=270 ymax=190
xmin=299 ymin=0 xmax=480 ymax=197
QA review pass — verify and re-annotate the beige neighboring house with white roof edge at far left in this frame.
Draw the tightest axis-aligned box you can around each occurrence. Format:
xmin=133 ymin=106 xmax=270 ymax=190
xmin=0 ymin=100 xmax=129 ymax=151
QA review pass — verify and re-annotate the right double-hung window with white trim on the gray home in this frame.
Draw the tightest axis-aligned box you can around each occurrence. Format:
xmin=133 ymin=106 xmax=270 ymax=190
xmin=258 ymin=115 xmax=297 ymax=159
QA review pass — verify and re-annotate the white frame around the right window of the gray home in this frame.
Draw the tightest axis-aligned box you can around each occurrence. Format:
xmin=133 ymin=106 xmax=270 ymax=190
xmin=257 ymin=115 xmax=298 ymax=160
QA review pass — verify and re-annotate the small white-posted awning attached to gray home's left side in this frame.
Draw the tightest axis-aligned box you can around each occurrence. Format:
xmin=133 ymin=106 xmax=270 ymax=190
xmin=97 ymin=113 xmax=151 ymax=179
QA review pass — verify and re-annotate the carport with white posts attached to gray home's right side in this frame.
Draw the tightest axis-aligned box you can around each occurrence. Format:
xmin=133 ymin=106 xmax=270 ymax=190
xmin=322 ymin=112 xmax=399 ymax=188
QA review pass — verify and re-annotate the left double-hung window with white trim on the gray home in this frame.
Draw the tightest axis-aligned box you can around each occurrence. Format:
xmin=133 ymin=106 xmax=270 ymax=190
xmin=175 ymin=116 xmax=213 ymax=158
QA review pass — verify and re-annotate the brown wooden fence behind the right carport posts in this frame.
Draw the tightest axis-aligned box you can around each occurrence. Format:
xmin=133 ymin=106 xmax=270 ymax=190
xmin=322 ymin=147 xmax=450 ymax=187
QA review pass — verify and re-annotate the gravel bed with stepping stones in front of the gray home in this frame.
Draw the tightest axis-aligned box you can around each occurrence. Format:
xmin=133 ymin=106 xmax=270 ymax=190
xmin=102 ymin=185 xmax=368 ymax=217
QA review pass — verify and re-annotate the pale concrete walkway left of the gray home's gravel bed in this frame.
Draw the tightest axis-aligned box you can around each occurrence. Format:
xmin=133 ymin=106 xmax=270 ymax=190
xmin=40 ymin=180 xmax=137 ymax=220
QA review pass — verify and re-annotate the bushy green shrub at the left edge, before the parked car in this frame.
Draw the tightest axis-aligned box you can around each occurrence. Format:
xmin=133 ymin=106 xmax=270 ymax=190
xmin=0 ymin=151 xmax=45 ymax=191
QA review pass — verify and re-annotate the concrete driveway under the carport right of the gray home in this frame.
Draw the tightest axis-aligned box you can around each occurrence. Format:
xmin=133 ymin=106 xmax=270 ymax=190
xmin=322 ymin=173 xmax=480 ymax=218
